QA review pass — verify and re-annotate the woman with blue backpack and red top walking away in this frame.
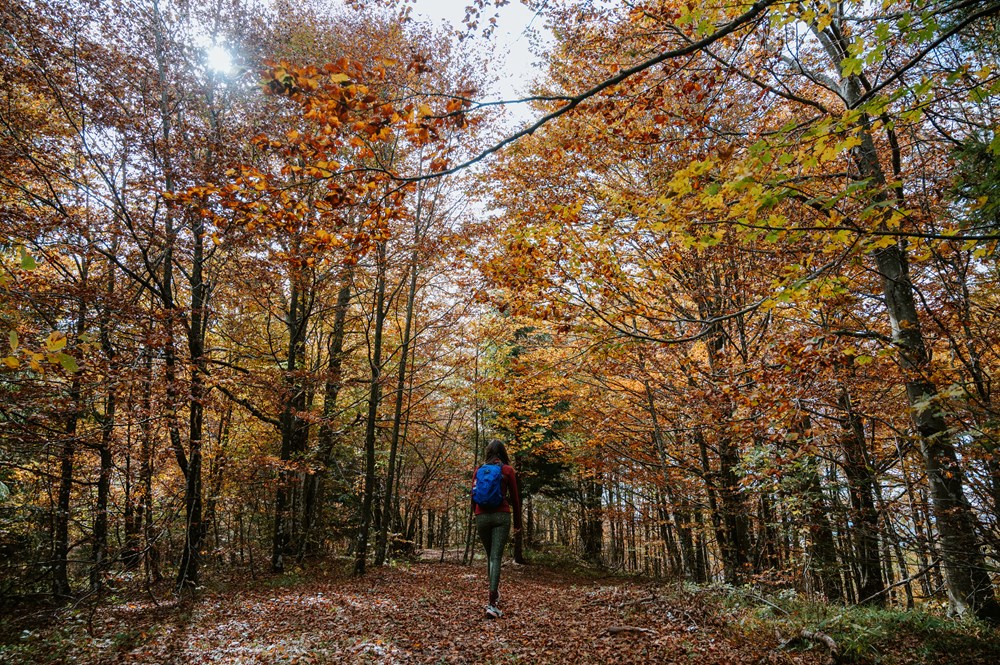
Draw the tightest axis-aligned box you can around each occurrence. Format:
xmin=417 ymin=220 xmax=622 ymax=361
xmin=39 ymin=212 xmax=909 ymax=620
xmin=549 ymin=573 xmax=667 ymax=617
xmin=472 ymin=440 xmax=521 ymax=619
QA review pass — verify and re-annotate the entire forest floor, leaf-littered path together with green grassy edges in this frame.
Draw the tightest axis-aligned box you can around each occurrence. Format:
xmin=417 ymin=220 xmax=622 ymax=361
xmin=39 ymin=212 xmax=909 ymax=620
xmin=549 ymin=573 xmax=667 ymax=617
xmin=0 ymin=556 xmax=1000 ymax=665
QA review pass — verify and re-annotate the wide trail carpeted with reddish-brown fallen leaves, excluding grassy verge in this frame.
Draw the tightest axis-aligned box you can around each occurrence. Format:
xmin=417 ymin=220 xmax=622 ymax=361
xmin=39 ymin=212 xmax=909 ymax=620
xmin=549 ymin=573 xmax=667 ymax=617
xmin=0 ymin=560 xmax=826 ymax=664
